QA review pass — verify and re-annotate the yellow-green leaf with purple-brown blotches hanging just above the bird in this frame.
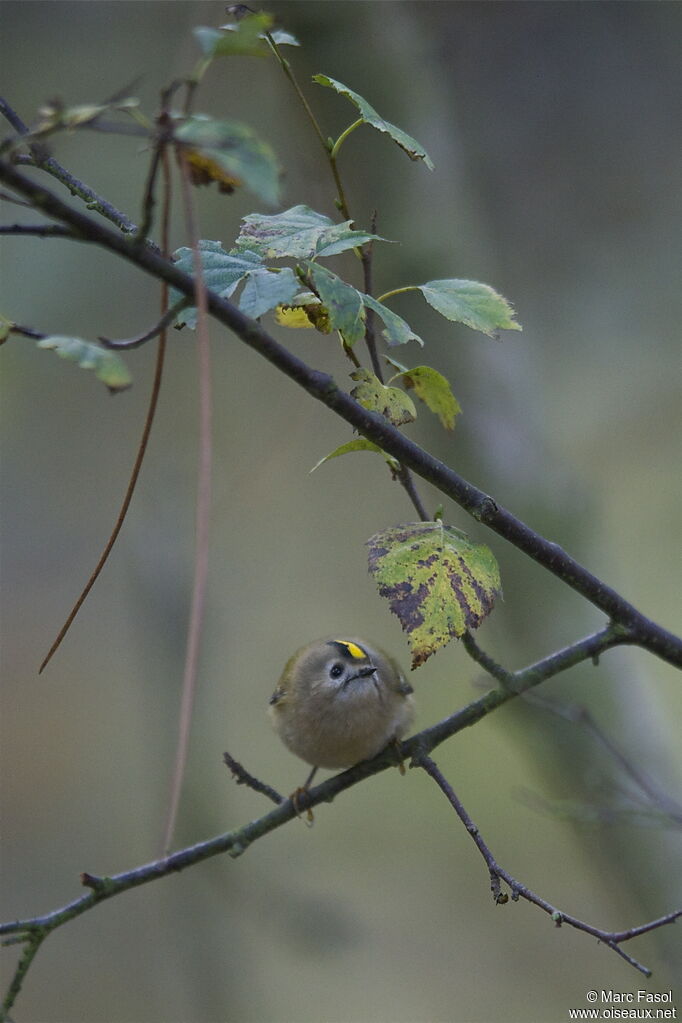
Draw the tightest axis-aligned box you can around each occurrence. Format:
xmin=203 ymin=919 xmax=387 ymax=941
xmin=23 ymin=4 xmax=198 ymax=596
xmin=367 ymin=522 xmax=501 ymax=668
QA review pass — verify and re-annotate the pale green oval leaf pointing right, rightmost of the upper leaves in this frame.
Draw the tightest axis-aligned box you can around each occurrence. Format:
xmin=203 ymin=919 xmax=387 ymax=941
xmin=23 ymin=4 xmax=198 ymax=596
xmin=417 ymin=279 xmax=521 ymax=338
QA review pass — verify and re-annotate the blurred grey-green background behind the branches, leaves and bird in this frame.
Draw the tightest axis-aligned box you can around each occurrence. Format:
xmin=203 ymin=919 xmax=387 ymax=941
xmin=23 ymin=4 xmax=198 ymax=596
xmin=0 ymin=0 xmax=682 ymax=1023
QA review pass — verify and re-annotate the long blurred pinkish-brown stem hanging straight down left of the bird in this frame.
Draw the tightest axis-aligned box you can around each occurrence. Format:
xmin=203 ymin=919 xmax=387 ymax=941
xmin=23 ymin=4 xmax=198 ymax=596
xmin=164 ymin=148 xmax=213 ymax=855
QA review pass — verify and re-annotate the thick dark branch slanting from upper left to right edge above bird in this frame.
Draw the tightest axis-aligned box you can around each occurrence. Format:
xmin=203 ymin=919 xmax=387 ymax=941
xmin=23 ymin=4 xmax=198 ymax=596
xmin=0 ymin=161 xmax=682 ymax=667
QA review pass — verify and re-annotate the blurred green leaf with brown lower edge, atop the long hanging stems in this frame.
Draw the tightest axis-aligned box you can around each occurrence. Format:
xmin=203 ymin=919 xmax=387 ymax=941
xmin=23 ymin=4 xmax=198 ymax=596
xmin=175 ymin=114 xmax=279 ymax=206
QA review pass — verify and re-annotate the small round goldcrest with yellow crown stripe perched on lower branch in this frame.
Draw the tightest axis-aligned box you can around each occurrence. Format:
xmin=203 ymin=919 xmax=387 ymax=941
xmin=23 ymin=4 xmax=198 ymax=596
xmin=269 ymin=638 xmax=414 ymax=781
